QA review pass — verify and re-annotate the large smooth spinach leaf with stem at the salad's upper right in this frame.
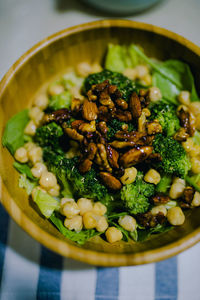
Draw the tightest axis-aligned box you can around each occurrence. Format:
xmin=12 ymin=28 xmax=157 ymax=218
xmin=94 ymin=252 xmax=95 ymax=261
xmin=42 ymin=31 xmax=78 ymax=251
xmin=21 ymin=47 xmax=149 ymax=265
xmin=133 ymin=45 xmax=199 ymax=104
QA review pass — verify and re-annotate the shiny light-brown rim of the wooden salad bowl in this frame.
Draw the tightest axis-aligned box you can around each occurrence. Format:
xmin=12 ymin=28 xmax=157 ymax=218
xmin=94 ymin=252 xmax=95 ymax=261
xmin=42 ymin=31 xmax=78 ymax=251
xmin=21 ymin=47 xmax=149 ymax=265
xmin=0 ymin=19 xmax=200 ymax=267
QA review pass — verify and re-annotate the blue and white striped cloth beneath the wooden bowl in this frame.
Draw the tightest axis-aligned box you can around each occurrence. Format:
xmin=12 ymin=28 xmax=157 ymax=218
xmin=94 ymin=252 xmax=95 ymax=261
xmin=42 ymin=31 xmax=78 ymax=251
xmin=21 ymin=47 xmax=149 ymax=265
xmin=0 ymin=206 xmax=200 ymax=300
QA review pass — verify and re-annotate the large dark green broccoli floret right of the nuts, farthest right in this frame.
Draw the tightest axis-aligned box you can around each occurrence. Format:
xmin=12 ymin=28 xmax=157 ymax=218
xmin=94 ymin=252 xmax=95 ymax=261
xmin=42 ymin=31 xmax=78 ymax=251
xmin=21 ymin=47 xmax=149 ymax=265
xmin=153 ymin=134 xmax=191 ymax=178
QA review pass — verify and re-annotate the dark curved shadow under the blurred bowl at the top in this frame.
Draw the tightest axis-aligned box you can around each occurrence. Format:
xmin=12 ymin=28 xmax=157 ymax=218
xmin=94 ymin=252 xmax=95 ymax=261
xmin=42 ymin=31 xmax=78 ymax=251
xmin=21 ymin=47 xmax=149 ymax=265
xmin=54 ymin=0 xmax=167 ymax=18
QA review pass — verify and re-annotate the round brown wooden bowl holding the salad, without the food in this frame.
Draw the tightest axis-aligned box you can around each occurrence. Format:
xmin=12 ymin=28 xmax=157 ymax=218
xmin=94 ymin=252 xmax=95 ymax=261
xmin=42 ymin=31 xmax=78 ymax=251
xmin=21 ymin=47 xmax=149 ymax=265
xmin=0 ymin=20 xmax=200 ymax=266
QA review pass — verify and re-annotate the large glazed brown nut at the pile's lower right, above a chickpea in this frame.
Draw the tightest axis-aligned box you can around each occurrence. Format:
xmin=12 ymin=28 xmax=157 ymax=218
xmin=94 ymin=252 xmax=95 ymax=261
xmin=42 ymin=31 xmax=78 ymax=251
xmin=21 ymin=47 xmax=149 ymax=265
xmin=120 ymin=146 xmax=153 ymax=168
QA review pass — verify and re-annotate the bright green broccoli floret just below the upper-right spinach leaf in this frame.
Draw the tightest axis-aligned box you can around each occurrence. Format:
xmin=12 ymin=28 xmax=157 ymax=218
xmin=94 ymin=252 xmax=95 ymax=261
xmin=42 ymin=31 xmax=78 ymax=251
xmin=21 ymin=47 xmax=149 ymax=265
xmin=150 ymin=101 xmax=180 ymax=136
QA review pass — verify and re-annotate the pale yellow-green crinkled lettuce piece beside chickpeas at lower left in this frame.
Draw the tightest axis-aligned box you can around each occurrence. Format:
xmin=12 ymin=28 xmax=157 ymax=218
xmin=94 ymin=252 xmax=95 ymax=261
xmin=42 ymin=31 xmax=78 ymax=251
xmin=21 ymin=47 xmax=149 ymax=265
xmin=33 ymin=189 xmax=60 ymax=218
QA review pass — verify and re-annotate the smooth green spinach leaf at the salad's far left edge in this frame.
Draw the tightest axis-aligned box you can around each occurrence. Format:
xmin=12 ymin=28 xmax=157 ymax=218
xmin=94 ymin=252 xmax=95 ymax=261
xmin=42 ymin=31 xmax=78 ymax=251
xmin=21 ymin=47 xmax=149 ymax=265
xmin=2 ymin=109 xmax=29 ymax=155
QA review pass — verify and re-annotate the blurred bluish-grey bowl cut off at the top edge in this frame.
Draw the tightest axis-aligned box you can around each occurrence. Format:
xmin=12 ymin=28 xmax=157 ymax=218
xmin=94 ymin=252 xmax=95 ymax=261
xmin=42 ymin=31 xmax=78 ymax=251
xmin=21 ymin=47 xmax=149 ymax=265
xmin=82 ymin=0 xmax=162 ymax=15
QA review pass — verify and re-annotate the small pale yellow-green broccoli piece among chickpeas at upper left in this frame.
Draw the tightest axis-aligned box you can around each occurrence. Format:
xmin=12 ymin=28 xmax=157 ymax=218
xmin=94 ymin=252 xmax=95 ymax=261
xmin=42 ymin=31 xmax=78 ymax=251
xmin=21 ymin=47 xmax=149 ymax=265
xmin=48 ymin=91 xmax=72 ymax=110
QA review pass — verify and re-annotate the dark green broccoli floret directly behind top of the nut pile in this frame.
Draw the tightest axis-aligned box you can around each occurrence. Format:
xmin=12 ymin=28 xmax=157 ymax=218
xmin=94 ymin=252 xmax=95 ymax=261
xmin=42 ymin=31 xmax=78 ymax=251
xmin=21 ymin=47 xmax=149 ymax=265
xmin=83 ymin=70 xmax=136 ymax=101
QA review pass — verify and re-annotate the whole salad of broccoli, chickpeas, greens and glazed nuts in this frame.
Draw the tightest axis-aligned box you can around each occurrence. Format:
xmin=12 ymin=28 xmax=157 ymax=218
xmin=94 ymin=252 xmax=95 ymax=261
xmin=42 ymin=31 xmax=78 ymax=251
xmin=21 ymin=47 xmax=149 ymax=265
xmin=2 ymin=44 xmax=200 ymax=244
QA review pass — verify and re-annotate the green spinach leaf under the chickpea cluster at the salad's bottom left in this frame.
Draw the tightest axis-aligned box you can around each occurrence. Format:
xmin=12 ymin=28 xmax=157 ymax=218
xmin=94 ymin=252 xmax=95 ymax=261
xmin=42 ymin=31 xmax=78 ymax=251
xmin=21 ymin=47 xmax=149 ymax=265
xmin=50 ymin=212 xmax=101 ymax=245
